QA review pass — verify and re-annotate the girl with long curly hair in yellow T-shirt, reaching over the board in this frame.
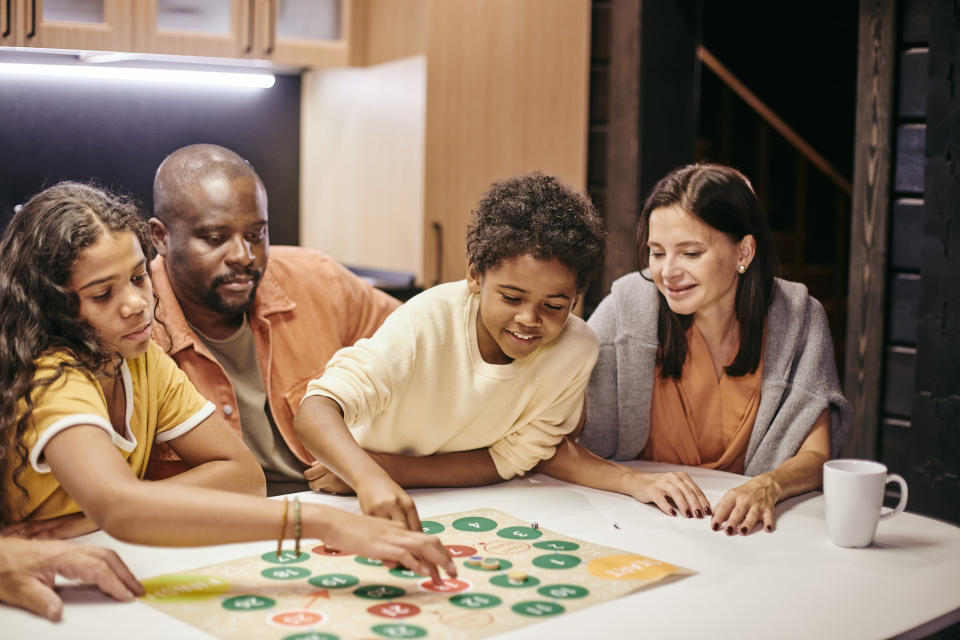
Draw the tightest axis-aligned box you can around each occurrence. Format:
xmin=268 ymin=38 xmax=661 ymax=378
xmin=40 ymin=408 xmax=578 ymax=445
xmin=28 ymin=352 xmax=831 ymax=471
xmin=0 ymin=183 xmax=454 ymax=580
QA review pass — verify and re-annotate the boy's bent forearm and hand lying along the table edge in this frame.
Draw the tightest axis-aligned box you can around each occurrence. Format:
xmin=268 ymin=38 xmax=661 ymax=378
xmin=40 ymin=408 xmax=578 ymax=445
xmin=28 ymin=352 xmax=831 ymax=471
xmin=303 ymin=449 xmax=503 ymax=493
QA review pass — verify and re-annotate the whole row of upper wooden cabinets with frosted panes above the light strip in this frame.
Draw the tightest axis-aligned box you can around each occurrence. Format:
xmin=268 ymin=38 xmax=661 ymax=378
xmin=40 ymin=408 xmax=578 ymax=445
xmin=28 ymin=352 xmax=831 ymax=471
xmin=0 ymin=0 xmax=354 ymax=67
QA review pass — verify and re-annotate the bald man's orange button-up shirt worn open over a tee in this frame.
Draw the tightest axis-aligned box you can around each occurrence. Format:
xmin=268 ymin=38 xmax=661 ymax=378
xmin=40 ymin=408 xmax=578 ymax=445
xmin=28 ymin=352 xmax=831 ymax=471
xmin=148 ymin=246 xmax=400 ymax=478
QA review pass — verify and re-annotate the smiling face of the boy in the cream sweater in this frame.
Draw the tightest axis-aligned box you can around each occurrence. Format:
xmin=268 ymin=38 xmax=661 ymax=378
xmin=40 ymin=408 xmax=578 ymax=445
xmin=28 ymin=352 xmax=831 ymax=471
xmin=467 ymin=254 xmax=577 ymax=364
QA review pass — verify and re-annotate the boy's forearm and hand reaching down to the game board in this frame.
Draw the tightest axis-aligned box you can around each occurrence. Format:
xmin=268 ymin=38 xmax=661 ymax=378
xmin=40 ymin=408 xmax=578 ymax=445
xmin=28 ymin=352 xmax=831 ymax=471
xmin=293 ymin=396 xmax=421 ymax=531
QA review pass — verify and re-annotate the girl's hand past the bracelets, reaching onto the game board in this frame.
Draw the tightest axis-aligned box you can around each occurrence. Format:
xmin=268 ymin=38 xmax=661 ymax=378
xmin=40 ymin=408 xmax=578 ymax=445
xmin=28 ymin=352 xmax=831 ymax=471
xmin=323 ymin=512 xmax=457 ymax=584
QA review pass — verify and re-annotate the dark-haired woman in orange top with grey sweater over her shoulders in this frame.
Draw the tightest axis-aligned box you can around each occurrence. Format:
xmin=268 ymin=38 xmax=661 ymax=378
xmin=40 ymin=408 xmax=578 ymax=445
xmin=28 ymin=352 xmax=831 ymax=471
xmin=580 ymin=164 xmax=850 ymax=535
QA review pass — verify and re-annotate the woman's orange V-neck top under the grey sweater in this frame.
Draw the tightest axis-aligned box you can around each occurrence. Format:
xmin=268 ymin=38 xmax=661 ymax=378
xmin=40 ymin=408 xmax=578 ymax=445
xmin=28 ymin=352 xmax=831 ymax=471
xmin=640 ymin=326 xmax=763 ymax=473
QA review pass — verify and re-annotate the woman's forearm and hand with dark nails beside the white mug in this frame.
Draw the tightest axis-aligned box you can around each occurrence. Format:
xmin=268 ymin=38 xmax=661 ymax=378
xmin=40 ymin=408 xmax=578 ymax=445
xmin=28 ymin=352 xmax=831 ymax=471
xmin=711 ymin=407 xmax=830 ymax=535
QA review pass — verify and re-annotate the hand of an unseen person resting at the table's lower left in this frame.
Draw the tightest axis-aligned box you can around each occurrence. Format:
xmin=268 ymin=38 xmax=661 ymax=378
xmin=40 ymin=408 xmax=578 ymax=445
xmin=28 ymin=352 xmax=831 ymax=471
xmin=0 ymin=538 xmax=144 ymax=622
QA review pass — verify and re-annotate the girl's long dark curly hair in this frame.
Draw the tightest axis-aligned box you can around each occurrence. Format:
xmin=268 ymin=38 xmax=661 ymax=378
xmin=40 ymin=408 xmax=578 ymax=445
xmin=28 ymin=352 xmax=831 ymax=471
xmin=0 ymin=182 xmax=152 ymax=524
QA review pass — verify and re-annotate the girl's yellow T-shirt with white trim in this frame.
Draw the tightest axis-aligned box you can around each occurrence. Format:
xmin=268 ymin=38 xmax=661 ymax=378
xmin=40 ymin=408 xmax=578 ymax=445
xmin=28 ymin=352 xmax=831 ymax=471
xmin=4 ymin=342 xmax=214 ymax=521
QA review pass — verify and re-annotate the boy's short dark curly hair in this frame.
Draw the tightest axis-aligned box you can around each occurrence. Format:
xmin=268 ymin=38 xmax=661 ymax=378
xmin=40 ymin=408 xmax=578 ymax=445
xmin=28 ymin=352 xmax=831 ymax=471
xmin=467 ymin=172 xmax=607 ymax=291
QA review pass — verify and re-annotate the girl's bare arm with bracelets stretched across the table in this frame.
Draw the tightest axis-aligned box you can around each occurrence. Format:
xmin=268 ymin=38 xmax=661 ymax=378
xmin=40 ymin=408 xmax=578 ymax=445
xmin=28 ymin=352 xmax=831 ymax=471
xmin=44 ymin=426 xmax=456 ymax=580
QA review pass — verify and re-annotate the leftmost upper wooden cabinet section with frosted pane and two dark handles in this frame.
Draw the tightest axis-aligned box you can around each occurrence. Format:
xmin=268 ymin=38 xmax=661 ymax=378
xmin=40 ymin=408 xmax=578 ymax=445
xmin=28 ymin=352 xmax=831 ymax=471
xmin=0 ymin=0 xmax=133 ymax=51
